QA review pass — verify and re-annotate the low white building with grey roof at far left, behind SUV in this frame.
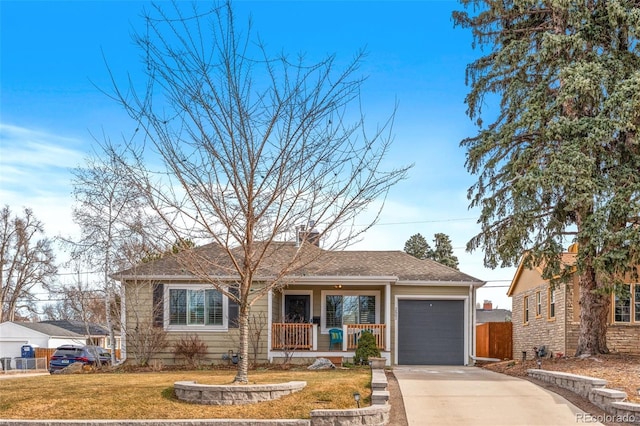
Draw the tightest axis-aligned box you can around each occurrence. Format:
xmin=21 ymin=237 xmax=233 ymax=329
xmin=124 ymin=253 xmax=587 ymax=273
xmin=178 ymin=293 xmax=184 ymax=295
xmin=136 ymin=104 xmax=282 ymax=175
xmin=0 ymin=321 xmax=120 ymax=358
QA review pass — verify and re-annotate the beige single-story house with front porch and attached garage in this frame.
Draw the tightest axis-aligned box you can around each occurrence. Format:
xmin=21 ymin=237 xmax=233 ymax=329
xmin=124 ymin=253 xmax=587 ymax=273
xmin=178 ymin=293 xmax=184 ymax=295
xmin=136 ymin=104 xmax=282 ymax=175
xmin=114 ymin=242 xmax=484 ymax=365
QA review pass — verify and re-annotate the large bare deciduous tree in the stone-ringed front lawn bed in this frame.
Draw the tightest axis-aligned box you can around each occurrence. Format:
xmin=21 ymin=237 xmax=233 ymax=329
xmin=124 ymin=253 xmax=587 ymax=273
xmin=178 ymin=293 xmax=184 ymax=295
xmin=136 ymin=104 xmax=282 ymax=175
xmin=110 ymin=3 xmax=409 ymax=383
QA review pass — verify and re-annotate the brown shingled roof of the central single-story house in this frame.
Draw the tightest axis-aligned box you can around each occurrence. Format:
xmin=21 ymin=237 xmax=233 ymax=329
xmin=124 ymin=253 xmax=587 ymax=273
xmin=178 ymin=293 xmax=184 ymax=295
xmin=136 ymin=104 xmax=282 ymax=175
xmin=114 ymin=242 xmax=484 ymax=285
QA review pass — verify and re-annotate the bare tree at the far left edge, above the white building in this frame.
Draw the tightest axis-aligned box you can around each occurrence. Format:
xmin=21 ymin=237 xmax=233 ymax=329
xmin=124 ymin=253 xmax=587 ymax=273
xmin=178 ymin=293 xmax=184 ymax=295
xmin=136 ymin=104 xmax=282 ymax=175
xmin=0 ymin=206 xmax=57 ymax=321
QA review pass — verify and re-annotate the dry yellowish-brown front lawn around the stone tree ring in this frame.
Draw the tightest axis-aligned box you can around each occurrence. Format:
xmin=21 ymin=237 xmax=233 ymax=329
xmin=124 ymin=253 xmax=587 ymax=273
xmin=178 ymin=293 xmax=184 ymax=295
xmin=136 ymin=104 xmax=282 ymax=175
xmin=0 ymin=368 xmax=371 ymax=420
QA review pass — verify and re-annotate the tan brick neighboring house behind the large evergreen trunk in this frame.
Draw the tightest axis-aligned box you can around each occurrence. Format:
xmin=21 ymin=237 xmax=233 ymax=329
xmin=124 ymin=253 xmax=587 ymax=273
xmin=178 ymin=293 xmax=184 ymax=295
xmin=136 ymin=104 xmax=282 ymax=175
xmin=507 ymin=248 xmax=640 ymax=359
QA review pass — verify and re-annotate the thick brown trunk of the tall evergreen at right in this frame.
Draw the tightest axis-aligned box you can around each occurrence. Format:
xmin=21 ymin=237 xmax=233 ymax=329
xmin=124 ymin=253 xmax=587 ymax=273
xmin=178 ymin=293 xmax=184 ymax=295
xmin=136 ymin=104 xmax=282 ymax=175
xmin=576 ymin=266 xmax=610 ymax=356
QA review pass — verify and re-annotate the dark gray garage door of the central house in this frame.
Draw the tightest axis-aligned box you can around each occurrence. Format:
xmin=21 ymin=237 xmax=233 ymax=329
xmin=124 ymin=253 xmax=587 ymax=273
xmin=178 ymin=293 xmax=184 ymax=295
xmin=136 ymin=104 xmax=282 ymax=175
xmin=398 ymin=300 xmax=464 ymax=365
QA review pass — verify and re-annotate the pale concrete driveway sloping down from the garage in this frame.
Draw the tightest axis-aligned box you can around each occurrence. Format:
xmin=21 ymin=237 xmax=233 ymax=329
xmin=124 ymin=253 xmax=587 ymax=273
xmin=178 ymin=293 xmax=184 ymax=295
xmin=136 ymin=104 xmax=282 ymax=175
xmin=392 ymin=366 xmax=601 ymax=426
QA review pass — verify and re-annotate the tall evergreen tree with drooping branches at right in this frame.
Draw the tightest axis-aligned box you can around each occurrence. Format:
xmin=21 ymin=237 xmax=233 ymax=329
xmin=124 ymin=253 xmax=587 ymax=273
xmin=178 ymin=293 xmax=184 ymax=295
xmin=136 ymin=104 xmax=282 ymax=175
xmin=453 ymin=0 xmax=640 ymax=354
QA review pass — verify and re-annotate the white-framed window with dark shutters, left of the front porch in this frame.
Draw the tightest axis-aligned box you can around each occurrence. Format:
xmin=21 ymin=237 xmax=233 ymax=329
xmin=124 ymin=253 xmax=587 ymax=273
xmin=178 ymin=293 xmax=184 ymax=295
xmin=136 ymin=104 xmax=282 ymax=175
xmin=165 ymin=285 xmax=228 ymax=330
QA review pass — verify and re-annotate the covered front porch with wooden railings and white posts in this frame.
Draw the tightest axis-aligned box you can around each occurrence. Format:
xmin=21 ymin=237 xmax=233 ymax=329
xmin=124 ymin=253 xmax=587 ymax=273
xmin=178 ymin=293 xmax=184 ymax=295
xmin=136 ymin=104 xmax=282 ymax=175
xmin=268 ymin=280 xmax=391 ymax=365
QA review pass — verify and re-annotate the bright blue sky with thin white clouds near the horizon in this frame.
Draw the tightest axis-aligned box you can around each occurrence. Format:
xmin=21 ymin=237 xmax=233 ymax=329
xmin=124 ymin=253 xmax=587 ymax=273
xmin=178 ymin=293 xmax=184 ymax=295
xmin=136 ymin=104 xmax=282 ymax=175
xmin=0 ymin=0 xmax=514 ymax=309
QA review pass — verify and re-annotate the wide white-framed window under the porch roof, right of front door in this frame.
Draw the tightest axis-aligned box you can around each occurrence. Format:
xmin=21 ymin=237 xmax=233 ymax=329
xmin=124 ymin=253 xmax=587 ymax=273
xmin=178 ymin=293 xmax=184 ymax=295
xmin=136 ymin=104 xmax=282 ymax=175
xmin=322 ymin=291 xmax=380 ymax=331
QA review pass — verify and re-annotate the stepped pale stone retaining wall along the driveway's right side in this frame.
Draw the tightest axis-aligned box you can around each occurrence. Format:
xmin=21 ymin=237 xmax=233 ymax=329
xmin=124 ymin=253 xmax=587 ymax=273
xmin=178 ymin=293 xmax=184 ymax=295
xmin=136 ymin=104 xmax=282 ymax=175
xmin=527 ymin=369 xmax=640 ymax=425
